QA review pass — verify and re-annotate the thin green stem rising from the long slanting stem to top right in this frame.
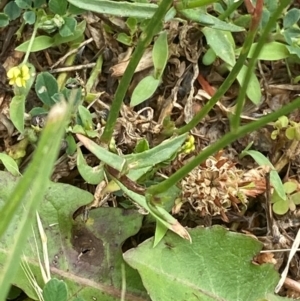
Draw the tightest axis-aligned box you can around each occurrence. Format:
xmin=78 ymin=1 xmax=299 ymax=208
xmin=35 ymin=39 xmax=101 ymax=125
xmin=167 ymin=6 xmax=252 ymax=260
xmin=231 ymin=0 xmax=290 ymax=131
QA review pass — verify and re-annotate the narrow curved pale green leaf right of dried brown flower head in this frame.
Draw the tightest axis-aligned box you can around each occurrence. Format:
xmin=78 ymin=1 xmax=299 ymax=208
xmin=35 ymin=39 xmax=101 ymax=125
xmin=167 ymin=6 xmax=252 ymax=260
xmin=242 ymin=150 xmax=287 ymax=201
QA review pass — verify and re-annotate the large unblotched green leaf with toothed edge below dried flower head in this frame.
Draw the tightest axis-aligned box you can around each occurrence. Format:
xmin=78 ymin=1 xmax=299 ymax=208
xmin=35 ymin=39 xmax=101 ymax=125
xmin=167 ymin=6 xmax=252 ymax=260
xmin=124 ymin=226 xmax=284 ymax=301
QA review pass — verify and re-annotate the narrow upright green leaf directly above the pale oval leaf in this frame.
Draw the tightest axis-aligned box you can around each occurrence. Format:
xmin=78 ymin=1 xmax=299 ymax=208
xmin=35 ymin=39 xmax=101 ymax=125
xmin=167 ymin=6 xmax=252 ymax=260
xmin=152 ymin=31 xmax=169 ymax=79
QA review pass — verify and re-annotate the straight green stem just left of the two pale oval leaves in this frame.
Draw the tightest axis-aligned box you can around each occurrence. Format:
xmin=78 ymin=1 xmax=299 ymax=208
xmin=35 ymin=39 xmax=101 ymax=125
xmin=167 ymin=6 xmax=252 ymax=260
xmin=101 ymin=0 xmax=172 ymax=144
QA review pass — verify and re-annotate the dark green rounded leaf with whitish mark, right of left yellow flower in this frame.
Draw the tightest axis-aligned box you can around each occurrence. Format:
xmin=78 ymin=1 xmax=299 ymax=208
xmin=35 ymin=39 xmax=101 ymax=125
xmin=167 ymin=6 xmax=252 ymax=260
xmin=35 ymin=72 xmax=58 ymax=107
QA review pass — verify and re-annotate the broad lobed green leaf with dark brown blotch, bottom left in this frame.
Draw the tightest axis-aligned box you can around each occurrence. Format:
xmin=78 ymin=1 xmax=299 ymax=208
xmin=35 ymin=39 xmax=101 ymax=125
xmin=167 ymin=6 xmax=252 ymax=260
xmin=0 ymin=171 xmax=149 ymax=301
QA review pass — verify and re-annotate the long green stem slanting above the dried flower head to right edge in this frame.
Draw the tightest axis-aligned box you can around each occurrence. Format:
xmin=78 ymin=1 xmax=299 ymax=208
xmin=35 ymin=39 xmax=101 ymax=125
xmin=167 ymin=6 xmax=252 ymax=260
xmin=147 ymin=97 xmax=300 ymax=196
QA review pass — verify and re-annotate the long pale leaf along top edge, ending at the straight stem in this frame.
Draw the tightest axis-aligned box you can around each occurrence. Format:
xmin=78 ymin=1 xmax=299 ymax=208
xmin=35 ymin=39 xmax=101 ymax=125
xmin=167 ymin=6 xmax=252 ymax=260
xmin=68 ymin=0 xmax=157 ymax=19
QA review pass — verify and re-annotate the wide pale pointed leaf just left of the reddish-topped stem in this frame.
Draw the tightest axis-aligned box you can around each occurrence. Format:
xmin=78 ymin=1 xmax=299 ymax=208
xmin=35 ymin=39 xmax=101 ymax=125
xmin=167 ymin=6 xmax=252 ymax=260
xmin=202 ymin=27 xmax=235 ymax=66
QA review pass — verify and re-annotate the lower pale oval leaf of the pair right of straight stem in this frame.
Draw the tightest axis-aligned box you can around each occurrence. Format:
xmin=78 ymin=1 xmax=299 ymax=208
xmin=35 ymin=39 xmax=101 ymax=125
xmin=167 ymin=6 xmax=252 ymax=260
xmin=130 ymin=75 xmax=160 ymax=107
